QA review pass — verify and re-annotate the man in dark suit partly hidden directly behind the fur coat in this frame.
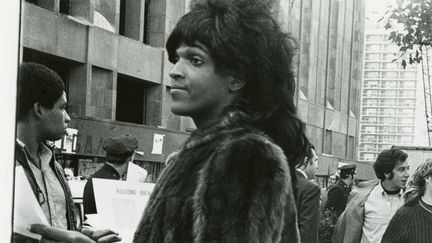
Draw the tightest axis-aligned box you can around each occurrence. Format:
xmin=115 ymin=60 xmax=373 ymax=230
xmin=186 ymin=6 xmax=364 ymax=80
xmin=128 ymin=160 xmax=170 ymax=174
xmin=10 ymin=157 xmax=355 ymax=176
xmin=295 ymin=145 xmax=320 ymax=243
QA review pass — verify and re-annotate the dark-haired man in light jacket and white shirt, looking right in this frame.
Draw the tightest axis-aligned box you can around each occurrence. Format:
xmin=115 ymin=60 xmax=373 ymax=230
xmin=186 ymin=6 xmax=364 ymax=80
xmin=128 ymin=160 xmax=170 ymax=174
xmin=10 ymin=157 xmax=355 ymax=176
xmin=332 ymin=148 xmax=409 ymax=243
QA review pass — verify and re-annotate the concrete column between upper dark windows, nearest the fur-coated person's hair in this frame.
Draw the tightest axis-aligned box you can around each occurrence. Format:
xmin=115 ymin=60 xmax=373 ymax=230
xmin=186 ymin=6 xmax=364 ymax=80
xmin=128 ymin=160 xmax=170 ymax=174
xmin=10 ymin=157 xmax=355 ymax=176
xmin=125 ymin=0 xmax=145 ymax=42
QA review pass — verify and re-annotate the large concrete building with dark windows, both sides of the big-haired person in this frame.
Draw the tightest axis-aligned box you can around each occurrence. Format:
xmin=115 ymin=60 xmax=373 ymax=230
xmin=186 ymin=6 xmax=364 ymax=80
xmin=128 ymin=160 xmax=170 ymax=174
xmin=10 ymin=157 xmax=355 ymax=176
xmin=21 ymin=0 xmax=365 ymax=181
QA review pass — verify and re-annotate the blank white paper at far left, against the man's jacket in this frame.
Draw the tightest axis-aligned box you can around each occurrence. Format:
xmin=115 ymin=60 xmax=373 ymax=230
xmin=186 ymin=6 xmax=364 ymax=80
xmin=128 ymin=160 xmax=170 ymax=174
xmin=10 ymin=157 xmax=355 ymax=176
xmin=13 ymin=166 xmax=49 ymax=240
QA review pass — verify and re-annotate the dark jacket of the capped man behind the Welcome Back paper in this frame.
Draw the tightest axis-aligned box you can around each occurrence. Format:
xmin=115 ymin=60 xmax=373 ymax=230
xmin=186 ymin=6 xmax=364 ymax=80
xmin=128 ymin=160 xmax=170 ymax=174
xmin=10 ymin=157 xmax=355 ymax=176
xmin=83 ymin=164 xmax=120 ymax=214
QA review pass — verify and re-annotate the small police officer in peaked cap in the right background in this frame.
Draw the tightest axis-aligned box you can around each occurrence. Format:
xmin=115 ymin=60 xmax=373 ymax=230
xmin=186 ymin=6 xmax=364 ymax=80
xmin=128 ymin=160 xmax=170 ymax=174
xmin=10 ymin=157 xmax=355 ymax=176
xmin=324 ymin=165 xmax=356 ymax=220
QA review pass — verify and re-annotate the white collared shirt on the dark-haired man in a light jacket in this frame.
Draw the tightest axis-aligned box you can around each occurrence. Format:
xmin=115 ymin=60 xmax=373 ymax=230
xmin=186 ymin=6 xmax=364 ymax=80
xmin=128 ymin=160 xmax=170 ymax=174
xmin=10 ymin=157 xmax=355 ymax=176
xmin=361 ymin=183 xmax=404 ymax=243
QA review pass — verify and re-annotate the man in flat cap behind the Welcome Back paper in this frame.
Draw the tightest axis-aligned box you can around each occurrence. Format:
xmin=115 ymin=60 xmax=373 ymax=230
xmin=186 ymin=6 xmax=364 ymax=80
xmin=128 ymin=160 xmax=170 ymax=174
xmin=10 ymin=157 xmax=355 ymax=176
xmin=83 ymin=134 xmax=138 ymax=214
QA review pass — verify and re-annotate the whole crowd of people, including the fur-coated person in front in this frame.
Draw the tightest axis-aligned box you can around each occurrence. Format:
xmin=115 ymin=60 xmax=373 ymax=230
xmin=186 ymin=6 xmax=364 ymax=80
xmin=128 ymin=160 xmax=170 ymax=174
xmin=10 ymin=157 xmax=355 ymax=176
xmin=13 ymin=0 xmax=432 ymax=243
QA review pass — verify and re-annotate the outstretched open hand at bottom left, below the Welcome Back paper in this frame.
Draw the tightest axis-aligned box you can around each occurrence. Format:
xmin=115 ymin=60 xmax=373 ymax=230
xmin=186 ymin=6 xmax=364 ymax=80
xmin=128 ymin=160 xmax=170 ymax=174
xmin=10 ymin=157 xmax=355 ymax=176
xmin=30 ymin=224 xmax=121 ymax=243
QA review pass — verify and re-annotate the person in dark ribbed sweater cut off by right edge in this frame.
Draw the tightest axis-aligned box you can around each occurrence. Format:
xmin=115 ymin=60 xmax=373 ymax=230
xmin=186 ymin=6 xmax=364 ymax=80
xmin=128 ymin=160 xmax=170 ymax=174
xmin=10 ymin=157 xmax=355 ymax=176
xmin=381 ymin=159 xmax=432 ymax=243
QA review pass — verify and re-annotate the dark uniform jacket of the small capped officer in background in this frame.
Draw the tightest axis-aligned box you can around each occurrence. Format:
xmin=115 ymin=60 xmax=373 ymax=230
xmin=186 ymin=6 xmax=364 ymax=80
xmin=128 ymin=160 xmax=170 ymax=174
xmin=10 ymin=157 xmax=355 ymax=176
xmin=324 ymin=180 xmax=351 ymax=219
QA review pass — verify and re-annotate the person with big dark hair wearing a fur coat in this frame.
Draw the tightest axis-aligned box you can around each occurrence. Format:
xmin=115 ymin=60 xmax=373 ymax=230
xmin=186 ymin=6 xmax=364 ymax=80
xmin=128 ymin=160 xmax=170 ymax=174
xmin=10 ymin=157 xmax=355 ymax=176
xmin=134 ymin=0 xmax=309 ymax=242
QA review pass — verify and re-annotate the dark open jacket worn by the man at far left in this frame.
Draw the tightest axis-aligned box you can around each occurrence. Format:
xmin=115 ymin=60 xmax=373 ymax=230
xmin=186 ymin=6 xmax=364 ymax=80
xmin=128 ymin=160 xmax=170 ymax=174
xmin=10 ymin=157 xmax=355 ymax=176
xmin=14 ymin=143 xmax=77 ymax=242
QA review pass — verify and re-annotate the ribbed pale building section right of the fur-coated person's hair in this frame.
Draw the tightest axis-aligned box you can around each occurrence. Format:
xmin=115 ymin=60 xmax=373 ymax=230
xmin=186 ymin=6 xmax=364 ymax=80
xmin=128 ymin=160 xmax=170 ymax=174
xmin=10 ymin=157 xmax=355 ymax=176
xmin=283 ymin=0 xmax=369 ymax=180
